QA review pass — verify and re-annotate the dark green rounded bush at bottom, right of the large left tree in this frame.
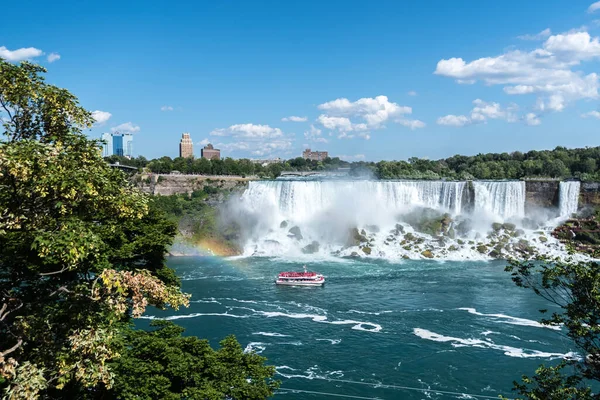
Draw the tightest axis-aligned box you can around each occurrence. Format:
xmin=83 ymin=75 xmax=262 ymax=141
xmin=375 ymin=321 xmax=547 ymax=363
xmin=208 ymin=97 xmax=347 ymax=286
xmin=111 ymin=321 xmax=279 ymax=400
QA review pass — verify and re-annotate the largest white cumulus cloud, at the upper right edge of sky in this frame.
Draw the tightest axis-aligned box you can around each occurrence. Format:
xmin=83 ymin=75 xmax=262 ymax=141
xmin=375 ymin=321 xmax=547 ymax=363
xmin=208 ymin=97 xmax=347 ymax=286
xmin=435 ymin=31 xmax=600 ymax=111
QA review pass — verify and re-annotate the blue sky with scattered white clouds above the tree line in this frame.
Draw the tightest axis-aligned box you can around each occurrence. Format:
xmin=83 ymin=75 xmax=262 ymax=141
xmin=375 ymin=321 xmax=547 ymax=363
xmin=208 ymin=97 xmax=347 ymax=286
xmin=0 ymin=0 xmax=600 ymax=161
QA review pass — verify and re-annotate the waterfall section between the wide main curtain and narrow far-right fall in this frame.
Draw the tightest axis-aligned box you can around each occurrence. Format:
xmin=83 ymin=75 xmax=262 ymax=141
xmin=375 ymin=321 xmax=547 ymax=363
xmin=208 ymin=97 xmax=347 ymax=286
xmin=473 ymin=181 xmax=525 ymax=219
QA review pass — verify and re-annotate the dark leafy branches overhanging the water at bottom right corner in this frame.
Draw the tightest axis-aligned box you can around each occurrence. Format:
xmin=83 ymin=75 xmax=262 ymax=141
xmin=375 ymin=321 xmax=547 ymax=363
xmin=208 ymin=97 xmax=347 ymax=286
xmin=506 ymin=260 xmax=600 ymax=399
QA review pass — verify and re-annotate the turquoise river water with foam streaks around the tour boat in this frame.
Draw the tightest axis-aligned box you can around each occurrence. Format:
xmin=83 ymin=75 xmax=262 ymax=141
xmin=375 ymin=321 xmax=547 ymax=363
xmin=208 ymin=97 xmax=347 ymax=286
xmin=141 ymin=257 xmax=575 ymax=399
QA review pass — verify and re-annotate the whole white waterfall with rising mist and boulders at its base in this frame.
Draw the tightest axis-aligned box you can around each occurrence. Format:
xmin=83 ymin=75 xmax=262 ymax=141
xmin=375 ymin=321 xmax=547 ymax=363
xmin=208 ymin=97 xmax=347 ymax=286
xmin=227 ymin=179 xmax=577 ymax=258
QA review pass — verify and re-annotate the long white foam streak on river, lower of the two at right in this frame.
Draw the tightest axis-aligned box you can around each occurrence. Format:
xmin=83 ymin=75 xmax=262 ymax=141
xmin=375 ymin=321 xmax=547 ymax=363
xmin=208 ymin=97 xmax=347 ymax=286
xmin=413 ymin=328 xmax=578 ymax=360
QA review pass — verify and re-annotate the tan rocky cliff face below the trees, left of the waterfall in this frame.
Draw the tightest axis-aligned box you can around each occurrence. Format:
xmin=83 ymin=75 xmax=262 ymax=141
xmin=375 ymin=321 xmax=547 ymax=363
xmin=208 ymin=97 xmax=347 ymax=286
xmin=137 ymin=174 xmax=254 ymax=196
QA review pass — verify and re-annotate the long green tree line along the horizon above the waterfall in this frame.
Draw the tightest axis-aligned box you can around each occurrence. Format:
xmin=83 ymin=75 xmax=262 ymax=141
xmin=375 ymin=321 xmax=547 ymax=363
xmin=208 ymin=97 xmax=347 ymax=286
xmin=106 ymin=147 xmax=600 ymax=181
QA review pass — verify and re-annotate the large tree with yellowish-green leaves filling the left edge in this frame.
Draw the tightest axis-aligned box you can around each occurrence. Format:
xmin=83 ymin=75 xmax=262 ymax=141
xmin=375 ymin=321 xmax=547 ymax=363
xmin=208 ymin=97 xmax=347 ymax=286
xmin=0 ymin=59 xmax=274 ymax=400
